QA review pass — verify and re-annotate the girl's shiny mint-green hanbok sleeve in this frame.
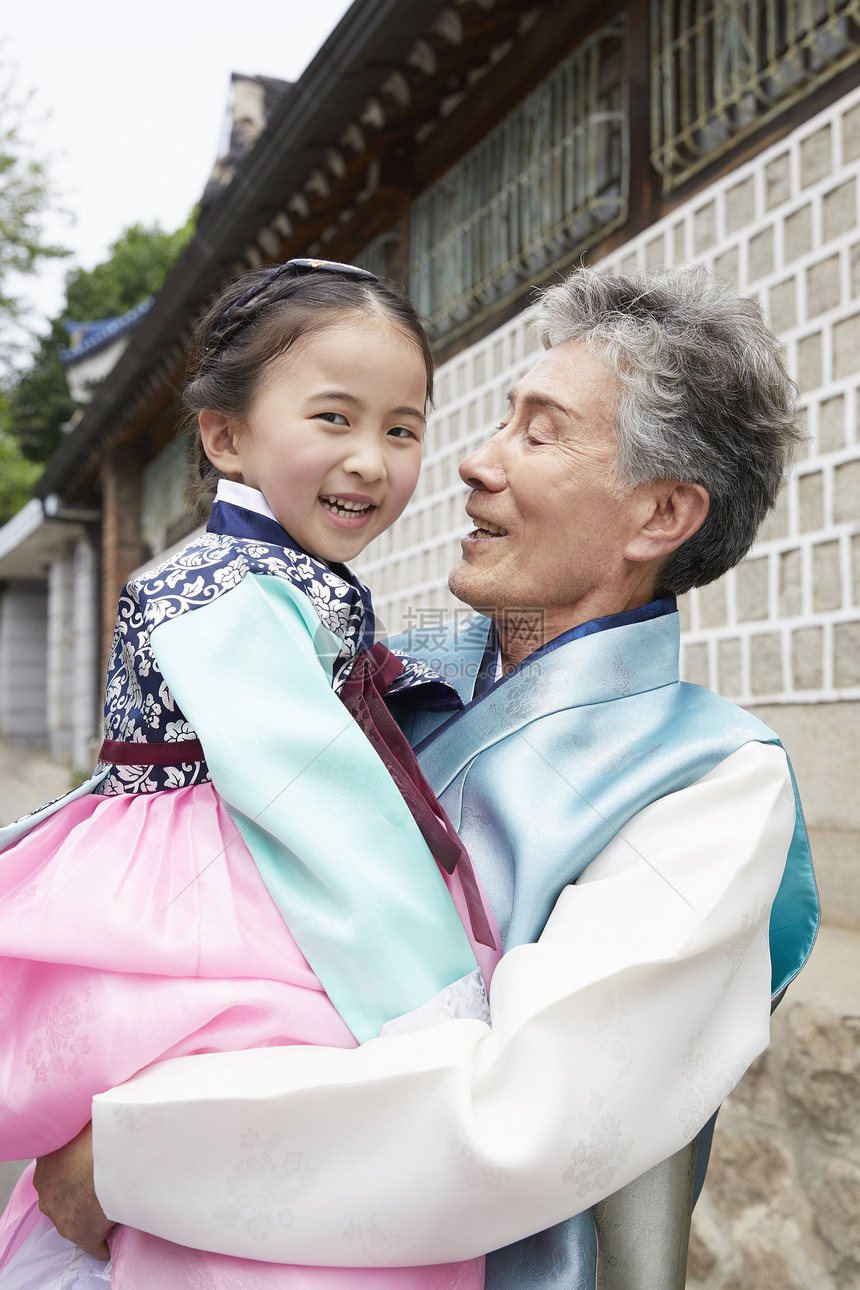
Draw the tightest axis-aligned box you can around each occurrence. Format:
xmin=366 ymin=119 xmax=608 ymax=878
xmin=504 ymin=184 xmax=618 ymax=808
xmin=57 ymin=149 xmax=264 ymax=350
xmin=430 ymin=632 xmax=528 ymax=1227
xmin=151 ymin=574 xmax=484 ymax=1040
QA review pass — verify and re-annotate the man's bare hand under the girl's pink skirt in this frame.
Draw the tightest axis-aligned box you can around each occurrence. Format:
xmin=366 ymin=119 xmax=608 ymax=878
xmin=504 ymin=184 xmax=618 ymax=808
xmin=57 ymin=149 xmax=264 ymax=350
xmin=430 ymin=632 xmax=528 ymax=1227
xmin=34 ymin=1125 xmax=113 ymax=1262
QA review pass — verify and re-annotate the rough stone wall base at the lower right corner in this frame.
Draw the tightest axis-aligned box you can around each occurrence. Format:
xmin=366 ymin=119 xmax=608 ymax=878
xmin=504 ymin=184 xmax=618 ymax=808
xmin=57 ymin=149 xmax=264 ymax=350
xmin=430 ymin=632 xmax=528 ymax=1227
xmin=687 ymin=928 xmax=860 ymax=1290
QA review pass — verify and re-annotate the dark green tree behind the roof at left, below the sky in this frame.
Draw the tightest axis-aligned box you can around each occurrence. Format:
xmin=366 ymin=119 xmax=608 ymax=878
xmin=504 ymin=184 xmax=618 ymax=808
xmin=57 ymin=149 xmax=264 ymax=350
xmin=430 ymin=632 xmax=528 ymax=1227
xmin=9 ymin=213 xmax=196 ymax=463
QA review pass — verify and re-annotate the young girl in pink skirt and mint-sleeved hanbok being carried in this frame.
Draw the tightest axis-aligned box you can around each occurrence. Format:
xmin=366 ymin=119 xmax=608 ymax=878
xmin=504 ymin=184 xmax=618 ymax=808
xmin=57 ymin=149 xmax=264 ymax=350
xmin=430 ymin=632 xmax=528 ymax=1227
xmin=0 ymin=261 xmax=495 ymax=1290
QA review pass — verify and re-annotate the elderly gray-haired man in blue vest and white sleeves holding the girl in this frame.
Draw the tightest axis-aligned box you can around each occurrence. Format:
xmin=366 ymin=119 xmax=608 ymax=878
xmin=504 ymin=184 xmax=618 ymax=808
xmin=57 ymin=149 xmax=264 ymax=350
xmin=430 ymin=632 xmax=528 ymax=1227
xmin=35 ymin=270 xmax=817 ymax=1290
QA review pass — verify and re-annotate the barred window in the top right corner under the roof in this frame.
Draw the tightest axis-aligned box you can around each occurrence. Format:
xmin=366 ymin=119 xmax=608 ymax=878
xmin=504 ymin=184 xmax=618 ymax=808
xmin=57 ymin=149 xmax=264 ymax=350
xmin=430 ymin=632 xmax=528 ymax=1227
xmin=651 ymin=0 xmax=860 ymax=191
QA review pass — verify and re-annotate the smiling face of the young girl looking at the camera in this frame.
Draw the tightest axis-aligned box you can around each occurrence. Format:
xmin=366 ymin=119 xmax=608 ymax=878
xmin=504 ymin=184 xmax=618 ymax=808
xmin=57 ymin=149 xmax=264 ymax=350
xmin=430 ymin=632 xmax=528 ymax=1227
xmin=200 ymin=316 xmax=427 ymax=562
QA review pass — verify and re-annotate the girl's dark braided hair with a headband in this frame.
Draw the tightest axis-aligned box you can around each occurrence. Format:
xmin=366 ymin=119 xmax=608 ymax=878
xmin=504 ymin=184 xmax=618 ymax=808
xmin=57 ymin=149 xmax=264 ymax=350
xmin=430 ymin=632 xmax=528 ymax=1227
xmin=182 ymin=268 xmax=433 ymax=520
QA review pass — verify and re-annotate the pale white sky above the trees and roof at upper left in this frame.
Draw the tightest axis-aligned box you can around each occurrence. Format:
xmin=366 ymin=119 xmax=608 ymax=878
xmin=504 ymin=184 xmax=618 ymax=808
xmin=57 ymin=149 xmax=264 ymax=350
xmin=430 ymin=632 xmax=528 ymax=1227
xmin=0 ymin=0 xmax=349 ymax=350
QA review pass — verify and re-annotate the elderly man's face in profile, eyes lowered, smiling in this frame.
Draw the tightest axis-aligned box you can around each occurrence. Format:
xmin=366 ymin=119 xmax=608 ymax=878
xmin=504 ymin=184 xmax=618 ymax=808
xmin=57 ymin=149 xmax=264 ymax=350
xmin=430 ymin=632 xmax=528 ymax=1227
xmin=449 ymin=341 xmax=650 ymax=640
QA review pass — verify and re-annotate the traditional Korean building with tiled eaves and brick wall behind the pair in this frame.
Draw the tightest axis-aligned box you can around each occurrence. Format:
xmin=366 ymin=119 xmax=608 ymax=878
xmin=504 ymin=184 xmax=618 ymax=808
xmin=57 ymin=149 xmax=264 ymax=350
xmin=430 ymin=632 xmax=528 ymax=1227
xmin=0 ymin=0 xmax=860 ymax=1290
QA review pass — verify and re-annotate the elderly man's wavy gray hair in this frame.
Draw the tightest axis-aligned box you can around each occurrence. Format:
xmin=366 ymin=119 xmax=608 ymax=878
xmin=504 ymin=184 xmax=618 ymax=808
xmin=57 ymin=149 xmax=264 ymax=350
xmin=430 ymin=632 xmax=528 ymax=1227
xmin=529 ymin=268 xmax=803 ymax=595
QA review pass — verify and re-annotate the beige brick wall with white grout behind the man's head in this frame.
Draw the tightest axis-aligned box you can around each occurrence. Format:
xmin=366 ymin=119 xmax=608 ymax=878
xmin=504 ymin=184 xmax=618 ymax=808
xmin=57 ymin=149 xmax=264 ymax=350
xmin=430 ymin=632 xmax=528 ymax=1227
xmin=360 ymin=90 xmax=860 ymax=706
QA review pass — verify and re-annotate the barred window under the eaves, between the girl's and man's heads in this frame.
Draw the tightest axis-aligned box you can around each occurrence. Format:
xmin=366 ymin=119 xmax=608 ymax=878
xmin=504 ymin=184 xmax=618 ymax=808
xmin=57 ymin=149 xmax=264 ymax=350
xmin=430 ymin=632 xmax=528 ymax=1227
xmin=409 ymin=14 xmax=629 ymax=338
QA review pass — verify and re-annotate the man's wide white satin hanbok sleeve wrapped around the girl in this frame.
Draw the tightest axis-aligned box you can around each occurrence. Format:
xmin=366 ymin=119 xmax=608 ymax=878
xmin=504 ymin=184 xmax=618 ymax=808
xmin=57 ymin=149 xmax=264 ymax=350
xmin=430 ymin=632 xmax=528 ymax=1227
xmin=93 ymin=743 xmax=794 ymax=1265
